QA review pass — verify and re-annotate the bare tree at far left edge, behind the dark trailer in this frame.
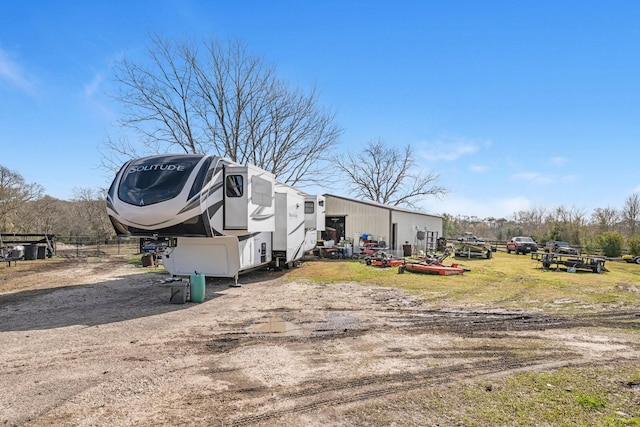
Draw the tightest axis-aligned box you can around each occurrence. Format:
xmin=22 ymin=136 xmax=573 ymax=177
xmin=0 ymin=165 xmax=44 ymax=232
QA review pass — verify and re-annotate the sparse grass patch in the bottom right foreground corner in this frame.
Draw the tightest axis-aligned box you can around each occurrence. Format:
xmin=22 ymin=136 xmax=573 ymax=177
xmin=347 ymin=365 xmax=640 ymax=427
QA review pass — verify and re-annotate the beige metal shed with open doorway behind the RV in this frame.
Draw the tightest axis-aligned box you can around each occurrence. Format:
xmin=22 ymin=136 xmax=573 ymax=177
xmin=321 ymin=194 xmax=442 ymax=255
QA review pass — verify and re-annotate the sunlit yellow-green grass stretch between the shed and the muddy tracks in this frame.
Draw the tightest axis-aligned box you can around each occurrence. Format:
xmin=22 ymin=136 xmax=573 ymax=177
xmin=288 ymin=253 xmax=640 ymax=311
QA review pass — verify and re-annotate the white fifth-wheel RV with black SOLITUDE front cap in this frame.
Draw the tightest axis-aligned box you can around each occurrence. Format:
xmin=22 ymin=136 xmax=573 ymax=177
xmin=107 ymin=154 xmax=325 ymax=281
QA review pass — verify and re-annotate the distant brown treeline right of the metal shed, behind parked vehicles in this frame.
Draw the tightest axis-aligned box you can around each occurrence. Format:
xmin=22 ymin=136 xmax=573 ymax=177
xmin=443 ymin=193 xmax=640 ymax=256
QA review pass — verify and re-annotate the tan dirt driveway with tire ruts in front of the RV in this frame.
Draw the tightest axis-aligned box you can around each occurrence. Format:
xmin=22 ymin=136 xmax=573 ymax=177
xmin=0 ymin=258 xmax=640 ymax=426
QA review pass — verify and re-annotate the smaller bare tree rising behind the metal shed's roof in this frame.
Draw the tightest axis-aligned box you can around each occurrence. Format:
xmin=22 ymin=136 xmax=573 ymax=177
xmin=335 ymin=140 xmax=447 ymax=208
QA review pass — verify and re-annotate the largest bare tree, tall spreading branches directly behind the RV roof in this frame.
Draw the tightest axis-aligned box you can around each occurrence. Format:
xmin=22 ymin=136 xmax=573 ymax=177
xmin=101 ymin=37 xmax=342 ymax=185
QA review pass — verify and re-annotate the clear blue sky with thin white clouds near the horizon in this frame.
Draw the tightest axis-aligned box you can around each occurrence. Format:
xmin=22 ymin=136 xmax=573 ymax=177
xmin=0 ymin=0 xmax=640 ymax=218
